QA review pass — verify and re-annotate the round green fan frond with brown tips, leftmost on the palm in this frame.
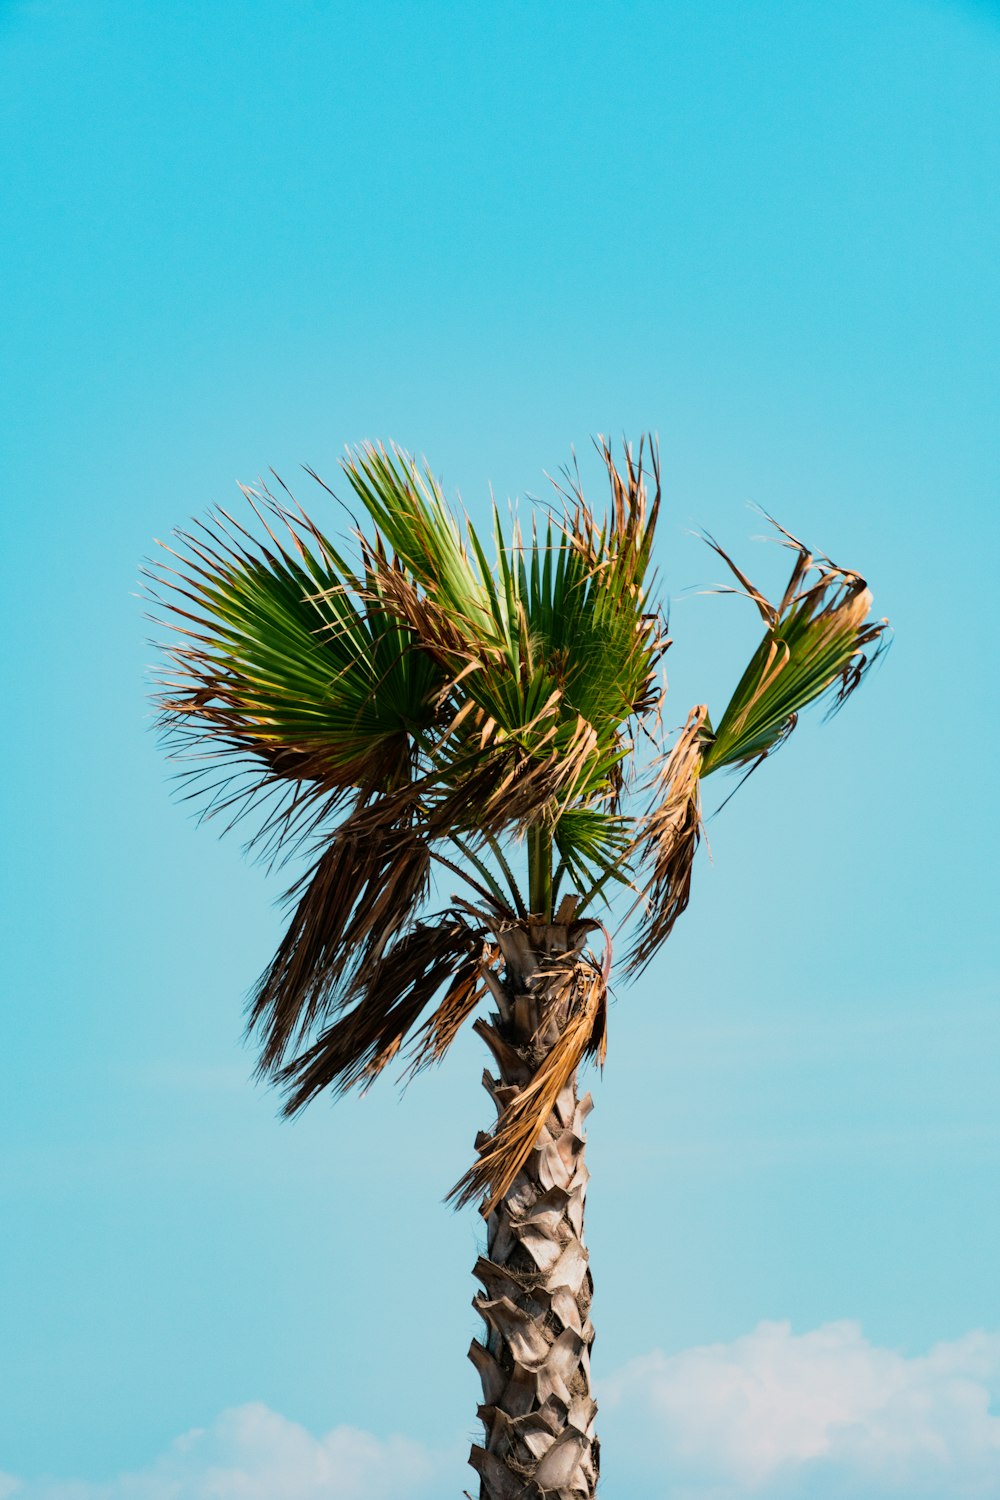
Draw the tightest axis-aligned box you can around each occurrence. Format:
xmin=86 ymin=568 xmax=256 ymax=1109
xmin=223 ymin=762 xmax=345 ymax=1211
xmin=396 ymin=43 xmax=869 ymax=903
xmin=148 ymin=492 xmax=444 ymax=852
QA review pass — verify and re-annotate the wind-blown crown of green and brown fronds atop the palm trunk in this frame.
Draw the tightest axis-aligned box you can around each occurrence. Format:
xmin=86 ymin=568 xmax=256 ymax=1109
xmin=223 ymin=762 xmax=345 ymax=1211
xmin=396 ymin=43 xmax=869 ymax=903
xmin=148 ymin=440 xmax=885 ymax=1164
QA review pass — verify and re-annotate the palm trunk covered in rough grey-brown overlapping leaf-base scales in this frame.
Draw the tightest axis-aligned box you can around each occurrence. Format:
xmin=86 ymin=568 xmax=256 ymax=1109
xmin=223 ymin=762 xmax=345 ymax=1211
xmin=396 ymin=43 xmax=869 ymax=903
xmin=469 ymin=924 xmax=600 ymax=1500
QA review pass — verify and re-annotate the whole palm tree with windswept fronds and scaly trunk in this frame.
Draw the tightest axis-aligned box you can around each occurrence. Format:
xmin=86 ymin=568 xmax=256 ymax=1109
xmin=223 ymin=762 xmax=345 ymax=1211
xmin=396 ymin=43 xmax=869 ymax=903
xmin=150 ymin=440 xmax=885 ymax=1500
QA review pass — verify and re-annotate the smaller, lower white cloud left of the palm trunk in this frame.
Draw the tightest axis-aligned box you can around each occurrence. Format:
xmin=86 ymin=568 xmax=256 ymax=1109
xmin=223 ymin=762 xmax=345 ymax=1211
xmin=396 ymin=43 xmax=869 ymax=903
xmin=0 ymin=1403 xmax=438 ymax=1500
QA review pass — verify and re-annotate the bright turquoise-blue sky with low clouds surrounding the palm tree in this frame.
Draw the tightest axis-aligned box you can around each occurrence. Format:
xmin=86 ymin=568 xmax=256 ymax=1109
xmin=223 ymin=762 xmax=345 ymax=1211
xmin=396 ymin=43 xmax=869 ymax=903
xmin=0 ymin=0 xmax=1000 ymax=1500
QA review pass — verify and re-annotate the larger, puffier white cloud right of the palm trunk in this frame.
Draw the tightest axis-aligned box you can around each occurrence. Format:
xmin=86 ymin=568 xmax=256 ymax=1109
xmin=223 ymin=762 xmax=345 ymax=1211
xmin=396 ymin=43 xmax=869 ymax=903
xmin=600 ymin=1323 xmax=1000 ymax=1500
